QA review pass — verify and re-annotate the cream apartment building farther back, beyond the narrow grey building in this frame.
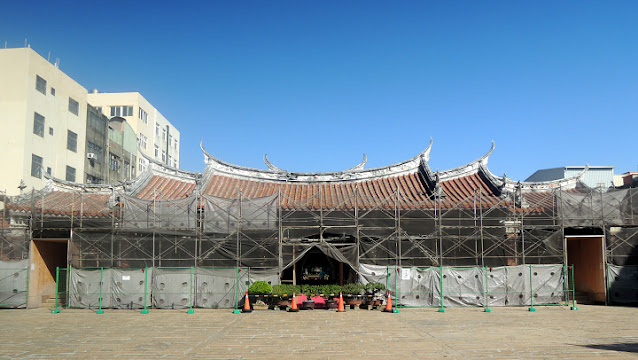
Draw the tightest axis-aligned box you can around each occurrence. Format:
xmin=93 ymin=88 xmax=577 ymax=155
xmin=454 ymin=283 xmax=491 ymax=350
xmin=88 ymin=90 xmax=181 ymax=174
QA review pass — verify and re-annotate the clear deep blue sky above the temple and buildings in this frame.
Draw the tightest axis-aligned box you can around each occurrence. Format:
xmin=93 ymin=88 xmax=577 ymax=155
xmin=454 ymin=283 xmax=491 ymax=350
xmin=0 ymin=1 xmax=638 ymax=180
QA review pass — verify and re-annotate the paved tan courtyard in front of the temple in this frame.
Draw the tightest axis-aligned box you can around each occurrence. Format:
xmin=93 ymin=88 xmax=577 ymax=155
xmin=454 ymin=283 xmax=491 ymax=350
xmin=0 ymin=305 xmax=638 ymax=360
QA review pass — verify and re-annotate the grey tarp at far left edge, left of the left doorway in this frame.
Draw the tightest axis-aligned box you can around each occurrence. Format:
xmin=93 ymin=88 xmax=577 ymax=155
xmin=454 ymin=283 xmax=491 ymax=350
xmin=0 ymin=259 xmax=29 ymax=308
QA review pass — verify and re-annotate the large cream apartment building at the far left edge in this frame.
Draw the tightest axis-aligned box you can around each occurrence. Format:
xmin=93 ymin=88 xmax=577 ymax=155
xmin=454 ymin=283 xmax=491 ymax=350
xmin=0 ymin=48 xmax=87 ymax=195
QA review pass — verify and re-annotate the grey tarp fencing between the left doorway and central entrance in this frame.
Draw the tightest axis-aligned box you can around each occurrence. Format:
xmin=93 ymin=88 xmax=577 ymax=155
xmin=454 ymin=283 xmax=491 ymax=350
xmin=67 ymin=268 xmax=279 ymax=308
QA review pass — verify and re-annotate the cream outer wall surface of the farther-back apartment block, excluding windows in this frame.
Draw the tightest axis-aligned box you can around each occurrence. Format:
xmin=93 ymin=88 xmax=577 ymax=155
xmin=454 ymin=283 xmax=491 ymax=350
xmin=88 ymin=92 xmax=181 ymax=173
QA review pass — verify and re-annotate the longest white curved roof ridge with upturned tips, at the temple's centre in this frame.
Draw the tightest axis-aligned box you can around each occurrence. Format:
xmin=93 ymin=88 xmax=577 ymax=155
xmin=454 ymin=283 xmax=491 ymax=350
xmin=200 ymin=139 xmax=433 ymax=182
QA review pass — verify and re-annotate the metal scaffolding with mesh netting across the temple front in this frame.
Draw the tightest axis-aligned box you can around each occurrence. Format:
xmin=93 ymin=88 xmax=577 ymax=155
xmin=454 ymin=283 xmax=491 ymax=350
xmin=0 ymin=185 xmax=638 ymax=272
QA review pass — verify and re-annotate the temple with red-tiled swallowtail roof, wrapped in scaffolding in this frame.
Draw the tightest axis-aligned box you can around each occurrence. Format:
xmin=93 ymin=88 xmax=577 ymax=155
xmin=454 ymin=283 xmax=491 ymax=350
xmin=0 ymin=142 xmax=638 ymax=308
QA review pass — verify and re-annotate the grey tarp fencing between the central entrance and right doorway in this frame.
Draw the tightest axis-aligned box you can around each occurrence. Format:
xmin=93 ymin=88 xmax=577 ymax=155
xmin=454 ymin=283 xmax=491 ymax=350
xmin=359 ymin=264 xmax=566 ymax=306
